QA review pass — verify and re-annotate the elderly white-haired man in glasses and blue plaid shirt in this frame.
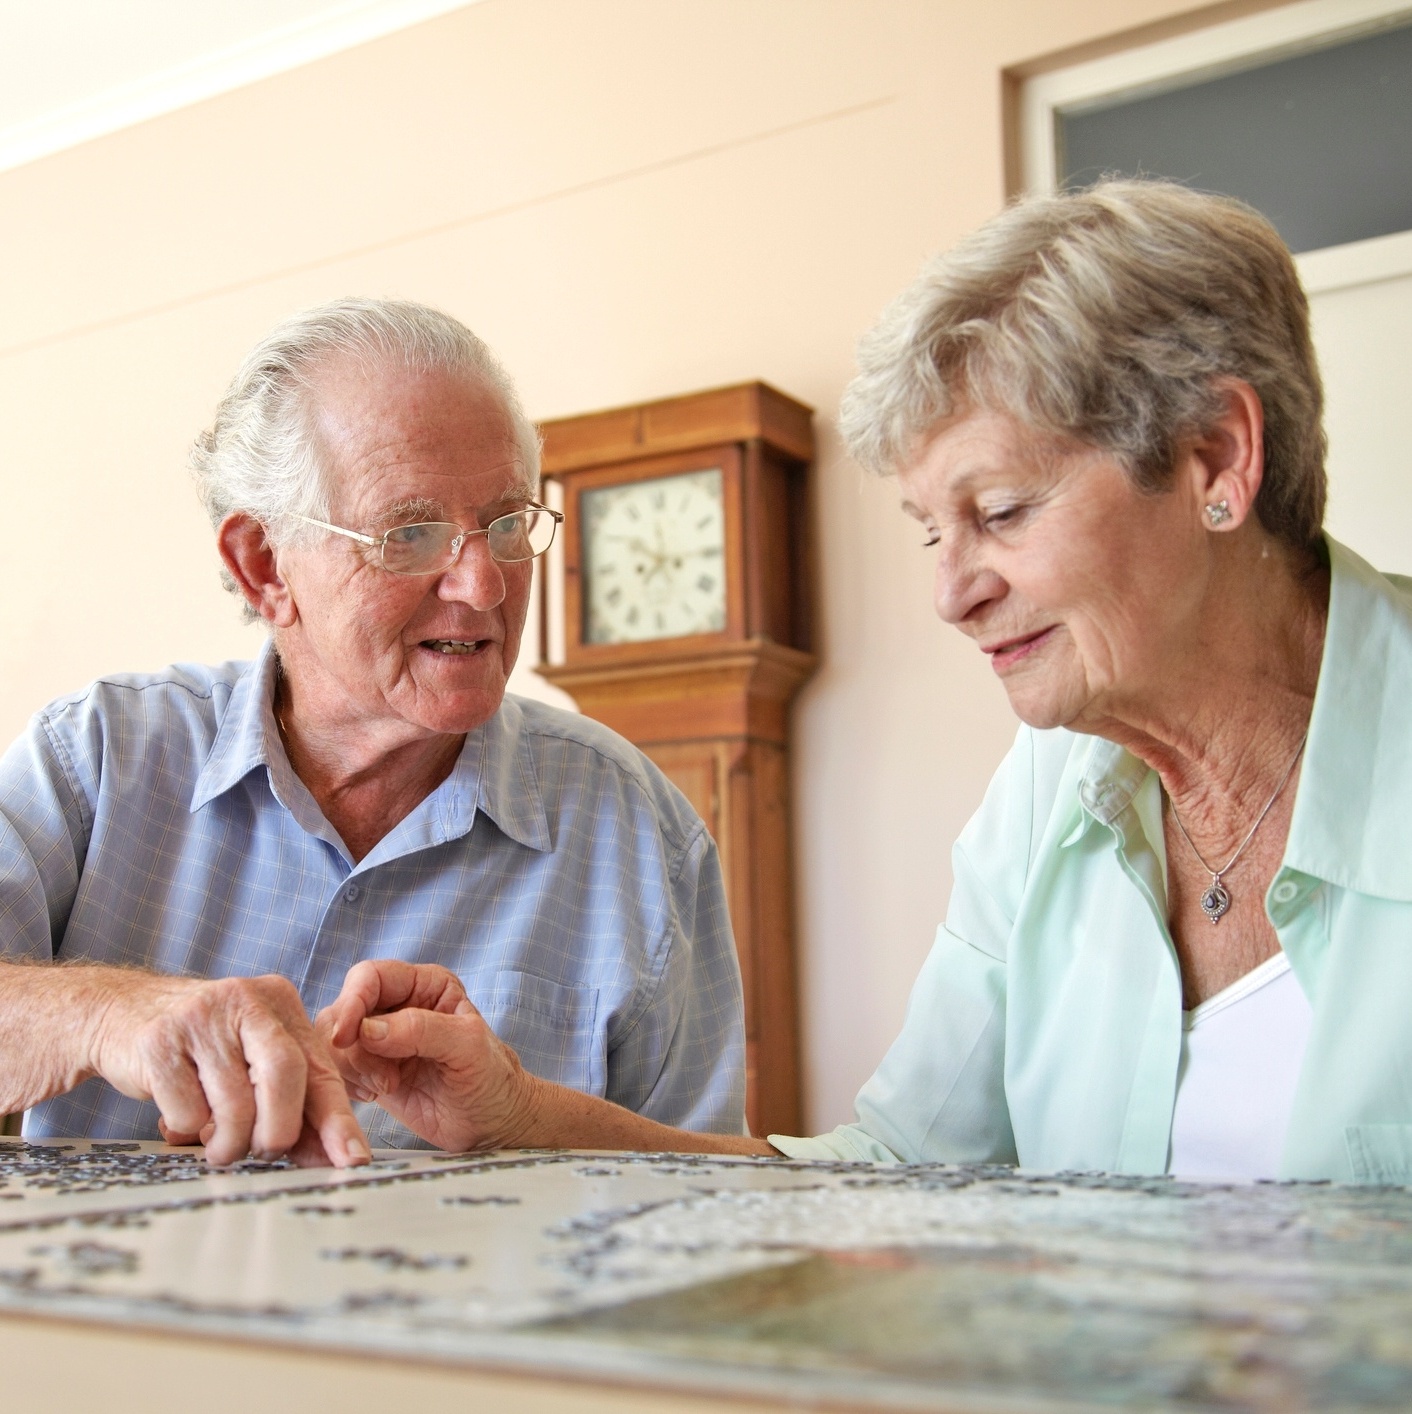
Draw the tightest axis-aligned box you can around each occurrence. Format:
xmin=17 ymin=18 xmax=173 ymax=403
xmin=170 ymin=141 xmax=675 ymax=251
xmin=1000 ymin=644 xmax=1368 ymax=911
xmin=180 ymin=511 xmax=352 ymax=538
xmin=0 ymin=300 xmax=743 ymax=1165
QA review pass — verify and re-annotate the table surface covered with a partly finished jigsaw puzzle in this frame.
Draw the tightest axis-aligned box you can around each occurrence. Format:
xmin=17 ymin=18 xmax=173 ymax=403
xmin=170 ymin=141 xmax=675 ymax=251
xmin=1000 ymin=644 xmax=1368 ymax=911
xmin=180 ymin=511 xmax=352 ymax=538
xmin=0 ymin=1140 xmax=1412 ymax=1414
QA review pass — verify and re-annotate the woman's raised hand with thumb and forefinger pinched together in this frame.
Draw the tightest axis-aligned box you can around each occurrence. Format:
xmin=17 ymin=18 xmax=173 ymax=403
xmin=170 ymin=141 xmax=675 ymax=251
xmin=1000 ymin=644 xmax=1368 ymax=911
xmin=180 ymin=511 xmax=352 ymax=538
xmin=315 ymin=960 xmax=534 ymax=1152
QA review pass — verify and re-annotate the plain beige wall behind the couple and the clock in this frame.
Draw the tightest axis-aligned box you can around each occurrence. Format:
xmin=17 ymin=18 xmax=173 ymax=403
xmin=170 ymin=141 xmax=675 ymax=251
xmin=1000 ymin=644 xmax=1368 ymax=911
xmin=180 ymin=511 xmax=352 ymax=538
xmin=0 ymin=0 xmax=1226 ymax=1127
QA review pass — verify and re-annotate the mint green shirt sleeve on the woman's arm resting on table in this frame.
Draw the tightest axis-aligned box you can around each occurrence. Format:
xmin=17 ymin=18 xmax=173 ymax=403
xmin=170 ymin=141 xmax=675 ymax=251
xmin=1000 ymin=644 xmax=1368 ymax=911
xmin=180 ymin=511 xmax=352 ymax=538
xmin=769 ymin=728 xmax=1035 ymax=1164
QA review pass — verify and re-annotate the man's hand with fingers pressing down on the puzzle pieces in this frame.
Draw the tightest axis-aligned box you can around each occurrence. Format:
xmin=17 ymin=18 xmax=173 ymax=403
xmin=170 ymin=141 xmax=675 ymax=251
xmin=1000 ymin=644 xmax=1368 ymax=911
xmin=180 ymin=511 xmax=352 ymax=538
xmin=84 ymin=969 xmax=372 ymax=1168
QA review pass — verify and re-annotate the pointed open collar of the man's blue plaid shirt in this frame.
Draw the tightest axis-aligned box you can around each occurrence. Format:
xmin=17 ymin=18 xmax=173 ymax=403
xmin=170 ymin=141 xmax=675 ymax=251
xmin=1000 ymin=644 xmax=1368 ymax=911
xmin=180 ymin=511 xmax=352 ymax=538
xmin=191 ymin=641 xmax=551 ymax=863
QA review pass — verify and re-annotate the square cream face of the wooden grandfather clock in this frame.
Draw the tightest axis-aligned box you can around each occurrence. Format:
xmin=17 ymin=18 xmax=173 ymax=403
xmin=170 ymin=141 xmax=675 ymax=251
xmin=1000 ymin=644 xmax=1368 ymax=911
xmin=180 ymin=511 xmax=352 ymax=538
xmin=579 ymin=467 xmax=725 ymax=643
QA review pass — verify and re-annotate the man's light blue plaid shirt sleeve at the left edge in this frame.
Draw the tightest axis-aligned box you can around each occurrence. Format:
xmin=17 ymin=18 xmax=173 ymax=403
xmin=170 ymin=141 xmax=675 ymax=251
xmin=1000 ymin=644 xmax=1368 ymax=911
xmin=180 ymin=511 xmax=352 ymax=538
xmin=0 ymin=713 xmax=92 ymax=962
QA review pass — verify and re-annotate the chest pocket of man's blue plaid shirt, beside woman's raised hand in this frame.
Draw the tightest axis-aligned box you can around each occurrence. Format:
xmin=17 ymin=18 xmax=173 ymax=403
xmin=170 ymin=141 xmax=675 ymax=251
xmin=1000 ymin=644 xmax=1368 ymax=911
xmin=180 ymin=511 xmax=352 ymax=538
xmin=466 ymin=967 xmax=608 ymax=1094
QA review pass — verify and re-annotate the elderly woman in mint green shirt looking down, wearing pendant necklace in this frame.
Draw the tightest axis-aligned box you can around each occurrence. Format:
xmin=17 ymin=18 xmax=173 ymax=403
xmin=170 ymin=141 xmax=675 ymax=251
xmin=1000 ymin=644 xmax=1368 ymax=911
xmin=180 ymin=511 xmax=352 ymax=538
xmin=327 ymin=182 xmax=1412 ymax=1181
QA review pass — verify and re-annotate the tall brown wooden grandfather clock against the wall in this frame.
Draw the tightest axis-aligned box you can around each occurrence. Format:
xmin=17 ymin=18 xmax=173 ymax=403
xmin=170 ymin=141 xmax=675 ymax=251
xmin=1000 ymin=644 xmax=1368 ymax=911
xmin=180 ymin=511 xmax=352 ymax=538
xmin=540 ymin=383 xmax=816 ymax=1134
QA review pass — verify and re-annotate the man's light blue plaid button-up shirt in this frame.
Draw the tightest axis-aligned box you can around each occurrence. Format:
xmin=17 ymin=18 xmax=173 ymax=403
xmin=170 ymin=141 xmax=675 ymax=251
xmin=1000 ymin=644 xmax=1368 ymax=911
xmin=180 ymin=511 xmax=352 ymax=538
xmin=0 ymin=648 xmax=745 ymax=1147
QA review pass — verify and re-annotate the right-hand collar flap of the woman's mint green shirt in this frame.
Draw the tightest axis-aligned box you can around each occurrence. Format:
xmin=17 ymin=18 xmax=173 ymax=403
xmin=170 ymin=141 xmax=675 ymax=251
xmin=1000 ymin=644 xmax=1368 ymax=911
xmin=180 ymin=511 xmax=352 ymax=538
xmin=1285 ymin=540 xmax=1412 ymax=902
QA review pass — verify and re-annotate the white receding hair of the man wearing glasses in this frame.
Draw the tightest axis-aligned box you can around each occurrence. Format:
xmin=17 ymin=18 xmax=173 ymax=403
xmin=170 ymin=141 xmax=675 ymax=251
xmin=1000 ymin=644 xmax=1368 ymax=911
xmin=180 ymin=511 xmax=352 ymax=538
xmin=191 ymin=298 xmax=540 ymax=619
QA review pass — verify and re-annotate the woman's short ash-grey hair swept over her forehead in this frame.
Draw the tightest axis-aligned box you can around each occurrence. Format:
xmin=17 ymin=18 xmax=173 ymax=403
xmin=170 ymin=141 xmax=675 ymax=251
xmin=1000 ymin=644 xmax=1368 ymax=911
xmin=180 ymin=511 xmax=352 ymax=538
xmin=840 ymin=181 xmax=1326 ymax=550
